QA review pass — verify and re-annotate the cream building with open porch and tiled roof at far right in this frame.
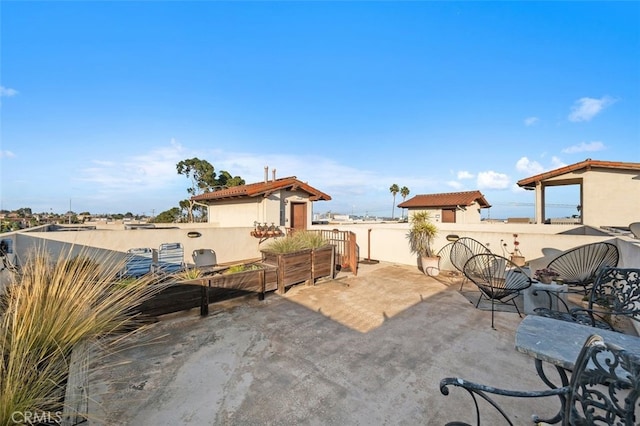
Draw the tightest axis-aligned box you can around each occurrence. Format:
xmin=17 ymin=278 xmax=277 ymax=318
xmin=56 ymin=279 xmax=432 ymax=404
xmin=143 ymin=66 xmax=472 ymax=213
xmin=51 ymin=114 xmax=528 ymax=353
xmin=518 ymin=158 xmax=640 ymax=227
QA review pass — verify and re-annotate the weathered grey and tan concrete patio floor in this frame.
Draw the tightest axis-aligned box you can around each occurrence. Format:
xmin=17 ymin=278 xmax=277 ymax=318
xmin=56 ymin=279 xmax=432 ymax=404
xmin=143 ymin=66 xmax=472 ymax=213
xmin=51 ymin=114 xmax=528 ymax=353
xmin=89 ymin=263 xmax=558 ymax=425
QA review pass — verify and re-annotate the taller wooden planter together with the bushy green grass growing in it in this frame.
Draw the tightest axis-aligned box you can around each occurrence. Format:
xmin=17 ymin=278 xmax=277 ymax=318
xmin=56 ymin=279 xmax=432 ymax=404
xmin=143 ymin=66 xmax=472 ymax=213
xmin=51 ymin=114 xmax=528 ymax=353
xmin=260 ymin=231 xmax=335 ymax=294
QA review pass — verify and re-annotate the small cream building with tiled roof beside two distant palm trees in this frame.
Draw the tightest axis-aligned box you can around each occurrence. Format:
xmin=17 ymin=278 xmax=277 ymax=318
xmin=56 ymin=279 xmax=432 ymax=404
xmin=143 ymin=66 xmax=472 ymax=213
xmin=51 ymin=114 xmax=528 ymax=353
xmin=398 ymin=191 xmax=491 ymax=223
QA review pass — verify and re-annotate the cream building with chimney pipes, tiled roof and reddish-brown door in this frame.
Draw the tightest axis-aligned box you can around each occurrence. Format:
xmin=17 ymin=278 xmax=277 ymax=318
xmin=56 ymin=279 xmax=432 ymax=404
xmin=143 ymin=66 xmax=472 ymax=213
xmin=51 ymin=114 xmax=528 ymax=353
xmin=191 ymin=167 xmax=331 ymax=229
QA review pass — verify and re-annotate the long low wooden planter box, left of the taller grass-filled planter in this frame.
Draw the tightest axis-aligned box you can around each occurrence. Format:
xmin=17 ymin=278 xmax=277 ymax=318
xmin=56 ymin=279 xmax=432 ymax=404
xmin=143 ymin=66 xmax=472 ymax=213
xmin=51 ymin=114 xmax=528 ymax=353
xmin=139 ymin=265 xmax=278 ymax=317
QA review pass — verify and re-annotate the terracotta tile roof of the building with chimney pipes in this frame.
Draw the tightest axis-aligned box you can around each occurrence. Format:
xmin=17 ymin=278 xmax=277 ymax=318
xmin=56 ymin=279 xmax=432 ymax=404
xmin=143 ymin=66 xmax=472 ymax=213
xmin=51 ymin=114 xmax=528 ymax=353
xmin=191 ymin=176 xmax=331 ymax=202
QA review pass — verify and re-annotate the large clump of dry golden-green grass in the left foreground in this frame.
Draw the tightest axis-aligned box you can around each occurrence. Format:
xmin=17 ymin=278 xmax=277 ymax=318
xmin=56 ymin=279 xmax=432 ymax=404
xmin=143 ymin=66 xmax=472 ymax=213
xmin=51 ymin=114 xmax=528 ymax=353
xmin=0 ymin=248 xmax=165 ymax=425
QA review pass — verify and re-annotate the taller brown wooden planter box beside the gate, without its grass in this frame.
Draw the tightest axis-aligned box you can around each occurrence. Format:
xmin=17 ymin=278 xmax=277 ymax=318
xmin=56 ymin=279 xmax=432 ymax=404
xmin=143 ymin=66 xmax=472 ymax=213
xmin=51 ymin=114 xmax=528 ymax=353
xmin=262 ymin=245 xmax=335 ymax=294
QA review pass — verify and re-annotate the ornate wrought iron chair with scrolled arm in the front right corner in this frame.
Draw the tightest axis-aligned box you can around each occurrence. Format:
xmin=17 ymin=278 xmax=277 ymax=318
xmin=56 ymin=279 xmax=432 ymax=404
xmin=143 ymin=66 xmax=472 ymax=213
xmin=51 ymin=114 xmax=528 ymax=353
xmin=440 ymin=335 xmax=640 ymax=426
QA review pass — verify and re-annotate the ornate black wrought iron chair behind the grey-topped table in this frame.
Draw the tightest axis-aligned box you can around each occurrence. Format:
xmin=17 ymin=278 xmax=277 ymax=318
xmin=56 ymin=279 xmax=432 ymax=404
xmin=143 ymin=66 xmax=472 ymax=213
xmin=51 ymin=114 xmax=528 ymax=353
xmin=534 ymin=268 xmax=640 ymax=331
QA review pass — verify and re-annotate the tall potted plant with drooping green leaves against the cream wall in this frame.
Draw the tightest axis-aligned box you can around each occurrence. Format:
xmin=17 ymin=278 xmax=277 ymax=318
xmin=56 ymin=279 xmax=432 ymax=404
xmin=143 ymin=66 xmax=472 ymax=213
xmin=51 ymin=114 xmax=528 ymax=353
xmin=407 ymin=211 xmax=440 ymax=277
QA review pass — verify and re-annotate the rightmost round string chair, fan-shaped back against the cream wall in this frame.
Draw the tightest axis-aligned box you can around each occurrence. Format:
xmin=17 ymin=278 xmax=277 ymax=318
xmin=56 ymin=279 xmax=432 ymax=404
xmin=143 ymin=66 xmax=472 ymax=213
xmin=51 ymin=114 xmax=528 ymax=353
xmin=547 ymin=242 xmax=620 ymax=294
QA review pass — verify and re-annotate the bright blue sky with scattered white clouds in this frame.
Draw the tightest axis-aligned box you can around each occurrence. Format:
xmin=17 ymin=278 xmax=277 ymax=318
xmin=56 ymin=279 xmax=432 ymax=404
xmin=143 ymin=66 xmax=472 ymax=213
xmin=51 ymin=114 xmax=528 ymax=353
xmin=0 ymin=1 xmax=640 ymax=218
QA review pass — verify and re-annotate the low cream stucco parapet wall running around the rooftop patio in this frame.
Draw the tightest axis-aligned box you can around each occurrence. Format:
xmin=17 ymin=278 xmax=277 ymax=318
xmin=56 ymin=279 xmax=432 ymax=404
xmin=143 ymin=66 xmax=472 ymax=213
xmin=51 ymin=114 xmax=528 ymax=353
xmin=0 ymin=223 xmax=640 ymax=292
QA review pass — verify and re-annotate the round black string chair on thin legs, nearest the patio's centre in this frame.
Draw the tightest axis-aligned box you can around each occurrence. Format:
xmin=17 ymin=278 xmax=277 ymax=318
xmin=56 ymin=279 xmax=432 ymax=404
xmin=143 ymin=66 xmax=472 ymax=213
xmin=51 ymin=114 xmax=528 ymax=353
xmin=463 ymin=253 xmax=533 ymax=328
